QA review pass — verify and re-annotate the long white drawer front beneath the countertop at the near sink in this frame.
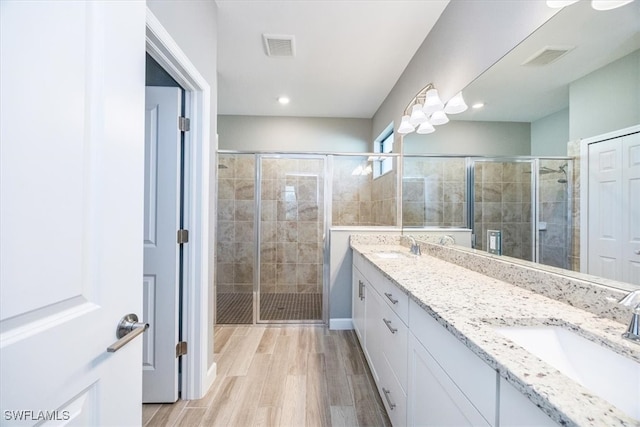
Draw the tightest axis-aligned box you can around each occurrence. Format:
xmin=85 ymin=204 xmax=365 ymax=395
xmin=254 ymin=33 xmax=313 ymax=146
xmin=409 ymin=301 xmax=497 ymax=424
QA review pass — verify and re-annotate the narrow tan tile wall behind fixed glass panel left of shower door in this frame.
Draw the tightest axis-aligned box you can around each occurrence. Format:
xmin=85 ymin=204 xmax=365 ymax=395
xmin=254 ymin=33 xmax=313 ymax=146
xmin=216 ymin=154 xmax=255 ymax=293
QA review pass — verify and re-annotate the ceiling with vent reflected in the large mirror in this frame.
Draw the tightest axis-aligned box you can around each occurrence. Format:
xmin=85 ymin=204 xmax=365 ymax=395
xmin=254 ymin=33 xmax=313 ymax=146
xmin=451 ymin=1 xmax=640 ymax=122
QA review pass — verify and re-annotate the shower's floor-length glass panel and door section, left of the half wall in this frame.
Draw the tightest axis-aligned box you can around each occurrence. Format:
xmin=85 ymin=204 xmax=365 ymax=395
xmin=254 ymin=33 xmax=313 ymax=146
xmin=216 ymin=153 xmax=326 ymax=323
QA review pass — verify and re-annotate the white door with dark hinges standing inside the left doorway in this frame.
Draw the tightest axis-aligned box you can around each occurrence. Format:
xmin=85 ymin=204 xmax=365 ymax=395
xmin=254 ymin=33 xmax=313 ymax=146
xmin=142 ymin=87 xmax=181 ymax=402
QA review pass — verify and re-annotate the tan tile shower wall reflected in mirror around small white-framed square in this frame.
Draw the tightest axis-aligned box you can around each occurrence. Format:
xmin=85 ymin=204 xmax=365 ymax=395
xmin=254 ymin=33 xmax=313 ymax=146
xmin=474 ymin=162 xmax=533 ymax=260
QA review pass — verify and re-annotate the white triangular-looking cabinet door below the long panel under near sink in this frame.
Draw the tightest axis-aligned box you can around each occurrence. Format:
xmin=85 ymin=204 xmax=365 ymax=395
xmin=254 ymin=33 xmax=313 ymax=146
xmin=407 ymin=334 xmax=489 ymax=427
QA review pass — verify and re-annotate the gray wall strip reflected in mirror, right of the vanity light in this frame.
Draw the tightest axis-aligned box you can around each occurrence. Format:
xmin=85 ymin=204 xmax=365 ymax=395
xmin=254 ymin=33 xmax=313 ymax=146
xmin=403 ymin=120 xmax=531 ymax=156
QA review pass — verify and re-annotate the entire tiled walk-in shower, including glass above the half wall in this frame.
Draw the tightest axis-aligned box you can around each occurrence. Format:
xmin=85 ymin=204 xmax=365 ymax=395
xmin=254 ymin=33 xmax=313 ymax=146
xmin=216 ymin=152 xmax=398 ymax=324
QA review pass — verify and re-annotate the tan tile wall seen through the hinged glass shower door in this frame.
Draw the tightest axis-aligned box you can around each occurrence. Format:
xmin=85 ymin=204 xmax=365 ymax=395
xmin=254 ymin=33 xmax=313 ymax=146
xmin=260 ymin=158 xmax=324 ymax=293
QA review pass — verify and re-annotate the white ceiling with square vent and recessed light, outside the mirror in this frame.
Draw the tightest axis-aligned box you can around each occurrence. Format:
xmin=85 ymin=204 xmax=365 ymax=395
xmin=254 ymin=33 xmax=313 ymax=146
xmin=216 ymin=0 xmax=449 ymax=118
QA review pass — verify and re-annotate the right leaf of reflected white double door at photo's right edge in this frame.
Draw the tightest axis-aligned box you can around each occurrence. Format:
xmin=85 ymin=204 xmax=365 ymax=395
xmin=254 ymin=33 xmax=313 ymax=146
xmin=622 ymin=133 xmax=640 ymax=285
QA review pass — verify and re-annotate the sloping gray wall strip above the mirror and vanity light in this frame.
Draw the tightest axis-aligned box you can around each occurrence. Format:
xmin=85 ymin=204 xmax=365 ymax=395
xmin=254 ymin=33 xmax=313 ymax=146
xmin=373 ymin=0 xmax=560 ymax=139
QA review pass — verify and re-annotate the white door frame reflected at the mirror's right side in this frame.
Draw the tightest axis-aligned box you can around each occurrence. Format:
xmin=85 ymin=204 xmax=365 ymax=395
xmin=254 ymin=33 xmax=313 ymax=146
xmin=580 ymin=124 xmax=640 ymax=273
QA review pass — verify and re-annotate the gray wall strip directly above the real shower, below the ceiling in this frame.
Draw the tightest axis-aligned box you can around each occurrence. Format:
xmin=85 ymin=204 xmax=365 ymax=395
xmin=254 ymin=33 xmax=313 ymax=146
xmin=218 ymin=116 xmax=373 ymax=153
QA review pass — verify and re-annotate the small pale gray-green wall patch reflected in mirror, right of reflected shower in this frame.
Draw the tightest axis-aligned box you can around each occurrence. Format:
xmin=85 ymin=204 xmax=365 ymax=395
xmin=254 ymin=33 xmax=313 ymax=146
xmin=531 ymin=108 xmax=569 ymax=156
